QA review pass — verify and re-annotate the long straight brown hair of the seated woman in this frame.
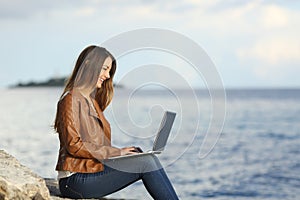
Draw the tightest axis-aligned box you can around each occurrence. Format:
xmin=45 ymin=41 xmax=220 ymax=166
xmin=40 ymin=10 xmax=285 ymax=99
xmin=54 ymin=45 xmax=117 ymax=128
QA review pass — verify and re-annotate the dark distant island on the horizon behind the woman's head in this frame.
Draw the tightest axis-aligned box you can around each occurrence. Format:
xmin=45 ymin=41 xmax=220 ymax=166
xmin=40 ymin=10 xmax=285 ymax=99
xmin=11 ymin=77 xmax=123 ymax=88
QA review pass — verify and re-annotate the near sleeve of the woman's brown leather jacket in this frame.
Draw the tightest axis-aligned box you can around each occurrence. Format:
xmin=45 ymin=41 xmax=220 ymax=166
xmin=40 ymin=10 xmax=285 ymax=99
xmin=58 ymin=94 xmax=121 ymax=160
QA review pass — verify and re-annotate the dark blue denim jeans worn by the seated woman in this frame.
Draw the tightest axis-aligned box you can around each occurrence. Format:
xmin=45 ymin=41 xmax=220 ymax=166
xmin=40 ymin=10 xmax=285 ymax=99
xmin=59 ymin=155 xmax=178 ymax=200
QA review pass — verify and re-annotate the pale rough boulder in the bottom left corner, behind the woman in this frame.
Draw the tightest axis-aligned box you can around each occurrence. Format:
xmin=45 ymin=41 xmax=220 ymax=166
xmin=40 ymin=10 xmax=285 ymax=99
xmin=0 ymin=150 xmax=50 ymax=200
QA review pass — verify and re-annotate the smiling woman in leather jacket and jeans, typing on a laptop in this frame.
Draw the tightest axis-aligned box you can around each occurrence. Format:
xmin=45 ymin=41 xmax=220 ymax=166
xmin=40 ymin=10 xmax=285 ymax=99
xmin=54 ymin=46 xmax=178 ymax=200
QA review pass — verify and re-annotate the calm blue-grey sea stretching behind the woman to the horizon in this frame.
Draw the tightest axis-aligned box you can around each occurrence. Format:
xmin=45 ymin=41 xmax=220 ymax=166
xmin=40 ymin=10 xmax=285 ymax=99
xmin=0 ymin=88 xmax=300 ymax=200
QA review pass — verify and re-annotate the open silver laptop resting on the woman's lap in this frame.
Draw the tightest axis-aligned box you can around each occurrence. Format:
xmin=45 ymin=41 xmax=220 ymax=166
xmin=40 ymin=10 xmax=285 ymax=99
xmin=108 ymin=111 xmax=176 ymax=160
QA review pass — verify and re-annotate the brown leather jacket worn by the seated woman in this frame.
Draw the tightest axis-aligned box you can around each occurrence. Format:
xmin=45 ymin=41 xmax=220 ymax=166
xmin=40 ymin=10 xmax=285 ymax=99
xmin=56 ymin=91 xmax=121 ymax=173
